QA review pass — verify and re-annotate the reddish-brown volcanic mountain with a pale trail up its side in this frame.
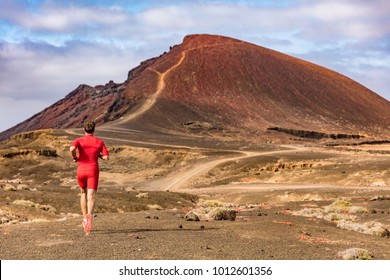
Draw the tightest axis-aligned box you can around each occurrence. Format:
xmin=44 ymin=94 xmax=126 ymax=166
xmin=0 ymin=35 xmax=390 ymax=139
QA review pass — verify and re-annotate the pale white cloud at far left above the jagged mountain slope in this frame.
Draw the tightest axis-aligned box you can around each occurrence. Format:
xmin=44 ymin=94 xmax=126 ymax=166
xmin=0 ymin=42 xmax=140 ymax=101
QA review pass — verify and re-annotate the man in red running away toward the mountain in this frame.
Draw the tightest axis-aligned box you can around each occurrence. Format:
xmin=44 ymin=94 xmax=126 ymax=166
xmin=70 ymin=120 xmax=109 ymax=235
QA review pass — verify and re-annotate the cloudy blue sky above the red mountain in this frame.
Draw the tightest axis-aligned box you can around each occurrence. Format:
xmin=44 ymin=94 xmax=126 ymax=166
xmin=0 ymin=0 xmax=390 ymax=131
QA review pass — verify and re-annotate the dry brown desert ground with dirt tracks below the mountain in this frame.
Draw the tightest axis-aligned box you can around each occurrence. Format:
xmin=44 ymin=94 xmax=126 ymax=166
xmin=0 ymin=127 xmax=390 ymax=260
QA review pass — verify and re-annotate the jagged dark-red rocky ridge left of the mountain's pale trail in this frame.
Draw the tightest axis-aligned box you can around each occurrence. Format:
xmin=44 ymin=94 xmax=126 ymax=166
xmin=0 ymin=54 xmax=159 ymax=140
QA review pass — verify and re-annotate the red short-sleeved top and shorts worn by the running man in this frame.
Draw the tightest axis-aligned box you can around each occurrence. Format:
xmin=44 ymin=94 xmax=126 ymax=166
xmin=72 ymin=134 xmax=108 ymax=190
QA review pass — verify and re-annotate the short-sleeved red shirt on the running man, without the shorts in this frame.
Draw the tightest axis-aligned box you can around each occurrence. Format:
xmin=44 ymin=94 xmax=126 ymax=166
xmin=72 ymin=134 xmax=108 ymax=171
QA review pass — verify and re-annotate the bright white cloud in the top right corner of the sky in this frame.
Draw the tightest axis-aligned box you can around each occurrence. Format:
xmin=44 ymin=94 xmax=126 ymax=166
xmin=292 ymin=0 xmax=390 ymax=41
